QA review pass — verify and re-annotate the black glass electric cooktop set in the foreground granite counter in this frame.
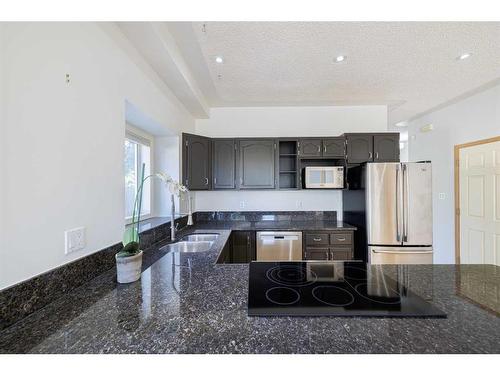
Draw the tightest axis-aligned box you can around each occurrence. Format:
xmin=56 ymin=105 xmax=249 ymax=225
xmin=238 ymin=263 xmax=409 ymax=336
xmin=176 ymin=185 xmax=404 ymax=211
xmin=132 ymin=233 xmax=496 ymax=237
xmin=248 ymin=261 xmax=446 ymax=318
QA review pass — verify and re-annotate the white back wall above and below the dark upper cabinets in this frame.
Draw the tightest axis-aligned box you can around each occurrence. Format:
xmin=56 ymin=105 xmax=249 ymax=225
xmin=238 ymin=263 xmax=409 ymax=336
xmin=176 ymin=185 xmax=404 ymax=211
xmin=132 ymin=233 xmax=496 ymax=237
xmin=195 ymin=106 xmax=387 ymax=218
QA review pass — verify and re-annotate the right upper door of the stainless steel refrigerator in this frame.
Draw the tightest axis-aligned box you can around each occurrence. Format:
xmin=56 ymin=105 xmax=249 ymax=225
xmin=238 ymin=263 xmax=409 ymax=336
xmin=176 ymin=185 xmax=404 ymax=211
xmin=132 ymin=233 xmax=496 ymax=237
xmin=402 ymin=163 xmax=432 ymax=246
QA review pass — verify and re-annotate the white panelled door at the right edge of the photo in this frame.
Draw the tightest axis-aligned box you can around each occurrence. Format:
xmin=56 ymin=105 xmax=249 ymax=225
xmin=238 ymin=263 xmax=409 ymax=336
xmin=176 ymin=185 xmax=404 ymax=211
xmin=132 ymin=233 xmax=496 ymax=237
xmin=459 ymin=141 xmax=500 ymax=266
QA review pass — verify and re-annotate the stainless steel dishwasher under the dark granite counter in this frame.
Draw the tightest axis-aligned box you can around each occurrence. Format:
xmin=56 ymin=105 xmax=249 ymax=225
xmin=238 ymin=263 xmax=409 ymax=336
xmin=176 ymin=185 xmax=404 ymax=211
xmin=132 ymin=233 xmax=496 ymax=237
xmin=257 ymin=232 xmax=302 ymax=261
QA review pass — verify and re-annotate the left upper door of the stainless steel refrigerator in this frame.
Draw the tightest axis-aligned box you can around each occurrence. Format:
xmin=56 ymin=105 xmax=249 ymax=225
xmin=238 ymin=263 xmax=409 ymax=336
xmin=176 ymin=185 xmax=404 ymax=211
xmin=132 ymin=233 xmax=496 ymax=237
xmin=365 ymin=163 xmax=403 ymax=245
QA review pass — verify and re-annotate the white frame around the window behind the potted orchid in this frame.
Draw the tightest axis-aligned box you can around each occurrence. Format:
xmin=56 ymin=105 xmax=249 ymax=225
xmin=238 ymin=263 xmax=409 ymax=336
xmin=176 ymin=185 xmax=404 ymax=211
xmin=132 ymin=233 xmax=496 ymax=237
xmin=123 ymin=123 xmax=154 ymax=224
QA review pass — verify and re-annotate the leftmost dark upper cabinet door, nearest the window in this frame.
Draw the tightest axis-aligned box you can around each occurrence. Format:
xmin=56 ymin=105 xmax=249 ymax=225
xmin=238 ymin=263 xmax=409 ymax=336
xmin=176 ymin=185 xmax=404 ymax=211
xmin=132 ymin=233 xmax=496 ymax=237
xmin=182 ymin=134 xmax=211 ymax=190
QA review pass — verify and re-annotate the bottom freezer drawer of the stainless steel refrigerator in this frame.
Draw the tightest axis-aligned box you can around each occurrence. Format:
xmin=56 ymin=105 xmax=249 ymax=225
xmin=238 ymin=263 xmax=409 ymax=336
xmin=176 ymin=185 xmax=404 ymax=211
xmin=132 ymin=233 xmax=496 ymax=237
xmin=368 ymin=246 xmax=433 ymax=264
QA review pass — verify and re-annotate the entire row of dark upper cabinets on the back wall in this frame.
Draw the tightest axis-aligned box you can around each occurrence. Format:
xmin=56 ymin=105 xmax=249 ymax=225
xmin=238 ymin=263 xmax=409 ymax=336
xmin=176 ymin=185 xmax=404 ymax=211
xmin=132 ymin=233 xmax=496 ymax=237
xmin=182 ymin=133 xmax=399 ymax=190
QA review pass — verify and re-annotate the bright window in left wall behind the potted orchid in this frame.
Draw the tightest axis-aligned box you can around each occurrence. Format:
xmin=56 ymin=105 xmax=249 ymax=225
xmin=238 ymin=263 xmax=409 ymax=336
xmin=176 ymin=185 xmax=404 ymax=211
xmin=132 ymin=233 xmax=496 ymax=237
xmin=124 ymin=126 xmax=152 ymax=222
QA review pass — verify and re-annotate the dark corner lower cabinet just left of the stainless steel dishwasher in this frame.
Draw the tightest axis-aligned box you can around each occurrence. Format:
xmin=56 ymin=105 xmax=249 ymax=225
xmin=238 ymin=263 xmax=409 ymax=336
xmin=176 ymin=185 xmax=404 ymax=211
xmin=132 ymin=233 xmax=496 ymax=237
xmin=217 ymin=231 xmax=256 ymax=263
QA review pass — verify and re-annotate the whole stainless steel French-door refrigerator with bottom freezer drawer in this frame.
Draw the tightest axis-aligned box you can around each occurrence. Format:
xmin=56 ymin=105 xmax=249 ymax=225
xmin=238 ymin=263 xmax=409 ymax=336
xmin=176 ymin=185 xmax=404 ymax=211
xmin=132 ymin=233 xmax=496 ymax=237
xmin=365 ymin=162 xmax=433 ymax=264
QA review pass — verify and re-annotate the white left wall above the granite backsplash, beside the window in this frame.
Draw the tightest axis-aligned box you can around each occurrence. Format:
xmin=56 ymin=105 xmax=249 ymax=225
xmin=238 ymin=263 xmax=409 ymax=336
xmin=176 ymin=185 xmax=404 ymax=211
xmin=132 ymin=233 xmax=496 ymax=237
xmin=0 ymin=23 xmax=194 ymax=289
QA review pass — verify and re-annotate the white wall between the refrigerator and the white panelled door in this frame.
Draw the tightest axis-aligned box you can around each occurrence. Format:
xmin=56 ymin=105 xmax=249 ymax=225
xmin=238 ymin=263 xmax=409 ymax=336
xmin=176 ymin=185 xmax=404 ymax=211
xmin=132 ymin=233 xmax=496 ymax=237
xmin=408 ymin=85 xmax=500 ymax=263
